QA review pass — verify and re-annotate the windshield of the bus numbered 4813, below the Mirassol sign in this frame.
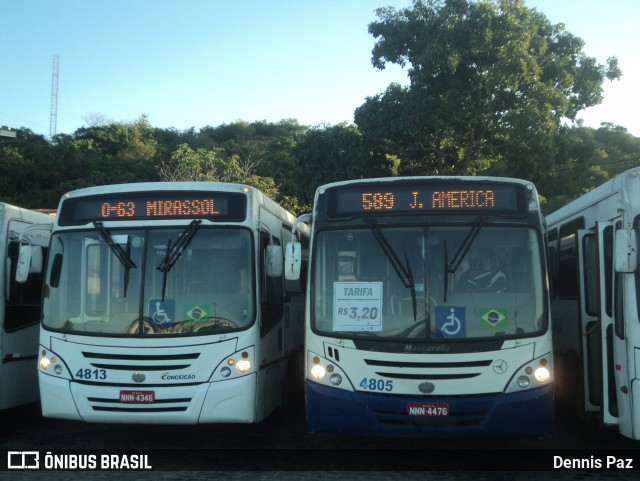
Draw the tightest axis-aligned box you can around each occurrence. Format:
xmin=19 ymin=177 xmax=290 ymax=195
xmin=43 ymin=227 xmax=254 ymax=336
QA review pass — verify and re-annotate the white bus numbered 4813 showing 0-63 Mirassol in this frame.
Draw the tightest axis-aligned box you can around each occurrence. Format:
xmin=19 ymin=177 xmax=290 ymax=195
xmin=39 ymin=182 xmax=304 ymax=423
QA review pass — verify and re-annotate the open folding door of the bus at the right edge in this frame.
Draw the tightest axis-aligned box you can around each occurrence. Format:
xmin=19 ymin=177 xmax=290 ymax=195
xmin=578 ymin=222 xmax=624 ymax=424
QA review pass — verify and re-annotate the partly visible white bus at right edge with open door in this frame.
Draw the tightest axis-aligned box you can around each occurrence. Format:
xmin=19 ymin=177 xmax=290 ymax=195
xmin=547 ymin=168 xmax=640 ymax=439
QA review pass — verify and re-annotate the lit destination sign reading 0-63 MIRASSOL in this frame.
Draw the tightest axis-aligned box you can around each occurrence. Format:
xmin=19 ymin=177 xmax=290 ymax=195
xmin=58 ymin=191 xmax=246 ymax=225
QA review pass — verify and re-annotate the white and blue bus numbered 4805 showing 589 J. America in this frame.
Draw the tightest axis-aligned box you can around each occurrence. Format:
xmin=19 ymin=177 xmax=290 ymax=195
xmin=285 ymin=177 xmax=553 ymax=437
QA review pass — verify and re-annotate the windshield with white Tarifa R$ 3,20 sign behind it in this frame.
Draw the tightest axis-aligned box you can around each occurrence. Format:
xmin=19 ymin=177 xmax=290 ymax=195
xmin=312 ymin=224 xmax=546 ymax=341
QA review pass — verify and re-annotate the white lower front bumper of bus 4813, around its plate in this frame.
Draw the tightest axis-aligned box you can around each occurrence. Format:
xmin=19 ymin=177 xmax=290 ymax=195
xmin=39 ymin=373 xmax=256 ymax=424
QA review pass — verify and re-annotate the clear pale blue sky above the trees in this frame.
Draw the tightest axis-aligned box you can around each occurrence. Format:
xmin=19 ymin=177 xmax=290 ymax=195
xmin=0 ymin=0 xmax=640 ymax=137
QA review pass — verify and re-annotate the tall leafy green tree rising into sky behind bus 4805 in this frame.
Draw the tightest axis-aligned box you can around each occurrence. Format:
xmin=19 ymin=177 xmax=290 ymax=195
xmin=355 ymin=0 xmax=621 ymax=176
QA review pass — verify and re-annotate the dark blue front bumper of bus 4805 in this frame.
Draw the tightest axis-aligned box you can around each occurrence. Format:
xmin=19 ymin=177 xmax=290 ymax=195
xmin=306 ymin=380 xmax=553 ymax=438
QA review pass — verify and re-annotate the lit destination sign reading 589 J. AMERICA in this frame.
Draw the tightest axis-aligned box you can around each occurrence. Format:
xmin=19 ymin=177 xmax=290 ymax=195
xmin=330 ymin=182 xmax=519 ymax=216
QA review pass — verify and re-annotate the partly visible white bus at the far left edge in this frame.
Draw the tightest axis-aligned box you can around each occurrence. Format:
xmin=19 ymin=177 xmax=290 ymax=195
xmin=0 ymin=202 xmax=53 ymax=409
